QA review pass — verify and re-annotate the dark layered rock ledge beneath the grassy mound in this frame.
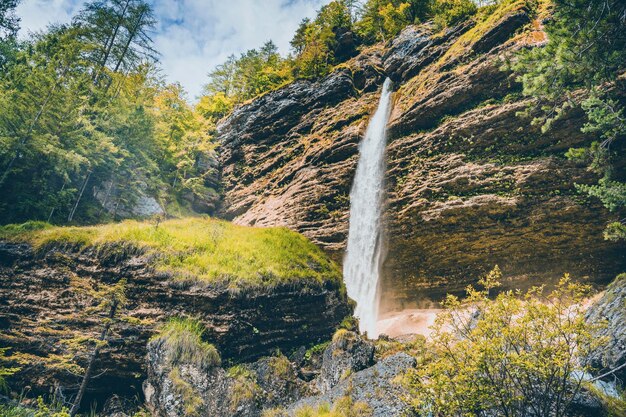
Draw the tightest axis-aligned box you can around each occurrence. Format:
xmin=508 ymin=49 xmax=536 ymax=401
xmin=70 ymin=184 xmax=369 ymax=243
xmin=0 ymin=243 xmax=351 ymax=404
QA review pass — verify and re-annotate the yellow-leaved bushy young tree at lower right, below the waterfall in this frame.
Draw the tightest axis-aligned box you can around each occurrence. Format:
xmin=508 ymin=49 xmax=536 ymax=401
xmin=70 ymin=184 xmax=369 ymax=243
xmin=408 ymin=267 xmax=602 ymax=417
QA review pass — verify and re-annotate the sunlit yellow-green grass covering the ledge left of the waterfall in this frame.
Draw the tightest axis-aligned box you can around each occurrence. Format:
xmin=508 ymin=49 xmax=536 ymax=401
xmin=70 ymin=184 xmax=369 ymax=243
xmin=0 ymin=218 xmax=341 ymax=287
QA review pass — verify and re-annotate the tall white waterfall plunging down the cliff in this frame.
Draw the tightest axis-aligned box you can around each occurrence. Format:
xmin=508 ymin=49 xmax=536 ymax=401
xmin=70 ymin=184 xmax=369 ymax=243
xmin=343 ymin=78 xmax=391 ymax=337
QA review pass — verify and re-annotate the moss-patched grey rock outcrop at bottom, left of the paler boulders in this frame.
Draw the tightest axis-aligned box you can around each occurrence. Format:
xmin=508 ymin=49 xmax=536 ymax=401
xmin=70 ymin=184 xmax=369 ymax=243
xmin=143 ymin=341 xmax=308 ymax=417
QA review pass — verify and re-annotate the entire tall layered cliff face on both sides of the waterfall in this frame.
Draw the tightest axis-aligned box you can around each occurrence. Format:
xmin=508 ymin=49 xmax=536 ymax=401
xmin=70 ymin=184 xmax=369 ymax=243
xmin=219 ymin=2 xmax=626 ymax=309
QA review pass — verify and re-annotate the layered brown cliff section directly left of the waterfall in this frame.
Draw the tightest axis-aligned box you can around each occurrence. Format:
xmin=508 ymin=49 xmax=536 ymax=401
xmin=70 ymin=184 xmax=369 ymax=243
xmin=219 ymin=48 xmax=383 ymax=251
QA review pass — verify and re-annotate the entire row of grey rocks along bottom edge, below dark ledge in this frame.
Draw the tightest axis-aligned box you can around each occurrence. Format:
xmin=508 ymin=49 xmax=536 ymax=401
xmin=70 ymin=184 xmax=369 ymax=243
xmin=143 ymin=330 xmax=416 ymax=417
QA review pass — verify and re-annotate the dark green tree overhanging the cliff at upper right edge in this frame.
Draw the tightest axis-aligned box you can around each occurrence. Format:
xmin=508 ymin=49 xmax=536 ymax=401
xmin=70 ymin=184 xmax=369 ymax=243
xmin=513 ymin=0 xmax=626 ymax=240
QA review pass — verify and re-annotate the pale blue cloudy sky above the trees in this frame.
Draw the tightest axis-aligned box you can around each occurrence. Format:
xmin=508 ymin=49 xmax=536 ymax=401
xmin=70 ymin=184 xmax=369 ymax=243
xmin=15 ymin=0 xmax=330 ymax=100
